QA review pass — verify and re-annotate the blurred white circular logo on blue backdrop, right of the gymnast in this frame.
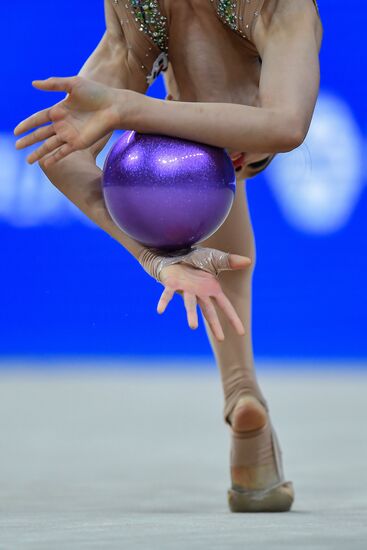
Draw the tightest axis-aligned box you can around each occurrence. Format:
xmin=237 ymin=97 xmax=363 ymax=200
xmin=265 ymin=94 xmax=364 ymax=234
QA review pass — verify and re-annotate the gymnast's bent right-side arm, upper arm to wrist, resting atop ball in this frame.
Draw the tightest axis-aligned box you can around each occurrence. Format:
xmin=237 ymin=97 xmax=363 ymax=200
xmin=115 ymin=0 xmax=322 ymax=153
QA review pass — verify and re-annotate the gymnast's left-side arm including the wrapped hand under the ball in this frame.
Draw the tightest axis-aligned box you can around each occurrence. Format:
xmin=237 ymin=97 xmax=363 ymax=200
xmin=23 ymin=0 xmax=249 ymax=340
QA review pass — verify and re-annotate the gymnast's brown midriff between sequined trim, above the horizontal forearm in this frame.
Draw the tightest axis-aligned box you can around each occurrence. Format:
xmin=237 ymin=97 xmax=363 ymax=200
xmin=165 ymin=0 xmax=261 ymax=105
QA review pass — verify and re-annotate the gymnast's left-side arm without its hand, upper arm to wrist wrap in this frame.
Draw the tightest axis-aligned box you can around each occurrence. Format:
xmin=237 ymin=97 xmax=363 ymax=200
xmin=39 ymin=0 xmax=147 ymax=258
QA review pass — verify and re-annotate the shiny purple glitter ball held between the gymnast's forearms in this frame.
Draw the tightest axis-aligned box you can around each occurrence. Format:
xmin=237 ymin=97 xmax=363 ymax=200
xmin=102 ymin=131 xmax=236 ymax=250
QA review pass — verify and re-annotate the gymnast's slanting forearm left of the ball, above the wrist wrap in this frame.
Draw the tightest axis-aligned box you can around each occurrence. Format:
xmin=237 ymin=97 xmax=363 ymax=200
xmin=40 ymin=150 xmax=144 ymax=258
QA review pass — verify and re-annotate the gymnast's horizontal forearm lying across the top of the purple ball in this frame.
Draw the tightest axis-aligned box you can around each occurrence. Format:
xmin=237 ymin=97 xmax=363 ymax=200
xmin=116 ymin=90 xmax=302 ymax=153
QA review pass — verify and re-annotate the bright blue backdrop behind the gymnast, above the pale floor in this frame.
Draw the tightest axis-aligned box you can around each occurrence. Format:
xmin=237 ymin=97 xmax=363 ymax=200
xmin=0 ymin=0 xmax=367 ymax=359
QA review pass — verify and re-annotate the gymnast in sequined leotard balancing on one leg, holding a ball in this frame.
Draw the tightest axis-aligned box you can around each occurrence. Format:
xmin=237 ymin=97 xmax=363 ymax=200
xmin=14 ymin=0 xmax=323 ymax=512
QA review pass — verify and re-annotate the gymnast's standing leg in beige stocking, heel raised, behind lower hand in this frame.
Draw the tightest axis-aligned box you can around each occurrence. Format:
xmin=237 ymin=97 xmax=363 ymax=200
xmin=200 ymin=181 xmax=284 ymax=489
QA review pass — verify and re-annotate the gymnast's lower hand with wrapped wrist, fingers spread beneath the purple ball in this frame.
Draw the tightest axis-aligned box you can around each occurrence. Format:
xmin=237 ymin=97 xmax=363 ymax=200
xmin=139 ymin=246 xmax=251 ymax=341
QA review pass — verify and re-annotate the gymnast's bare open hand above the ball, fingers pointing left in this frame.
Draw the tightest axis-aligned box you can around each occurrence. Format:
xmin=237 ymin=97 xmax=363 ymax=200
xmin=14 ymin=76 xmax=116 ymax=167
